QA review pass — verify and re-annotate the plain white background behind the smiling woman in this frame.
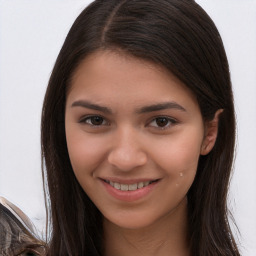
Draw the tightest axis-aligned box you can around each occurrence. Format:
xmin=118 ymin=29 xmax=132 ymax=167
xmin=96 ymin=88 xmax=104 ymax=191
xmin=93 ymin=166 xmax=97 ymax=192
xmin=0 ymin=0 xmax=256 ymax=256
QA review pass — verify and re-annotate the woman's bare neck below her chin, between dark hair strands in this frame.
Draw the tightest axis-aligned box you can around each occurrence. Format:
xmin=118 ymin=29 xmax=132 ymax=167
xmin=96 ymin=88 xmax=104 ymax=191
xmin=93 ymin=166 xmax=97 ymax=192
xmin=103 ymin=199 xmax=190 ymax=256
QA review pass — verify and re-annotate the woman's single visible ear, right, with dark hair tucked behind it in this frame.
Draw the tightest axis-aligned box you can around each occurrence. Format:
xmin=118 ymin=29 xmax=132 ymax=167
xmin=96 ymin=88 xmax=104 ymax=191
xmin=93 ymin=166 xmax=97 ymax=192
xmin=201 ymin=109 xmax=223 ymax=155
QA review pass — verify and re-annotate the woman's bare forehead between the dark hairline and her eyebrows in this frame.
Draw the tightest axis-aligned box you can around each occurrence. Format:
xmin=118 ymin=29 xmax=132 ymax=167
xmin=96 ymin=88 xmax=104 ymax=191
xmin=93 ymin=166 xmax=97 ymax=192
xmin=68 ymin=51 xmax=197 ymax=110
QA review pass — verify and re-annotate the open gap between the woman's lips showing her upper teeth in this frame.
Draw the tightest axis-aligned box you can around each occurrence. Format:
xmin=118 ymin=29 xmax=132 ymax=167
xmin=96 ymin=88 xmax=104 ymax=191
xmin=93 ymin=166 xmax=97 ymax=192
xmin=103 ymin=179 xmax=159 ymax=191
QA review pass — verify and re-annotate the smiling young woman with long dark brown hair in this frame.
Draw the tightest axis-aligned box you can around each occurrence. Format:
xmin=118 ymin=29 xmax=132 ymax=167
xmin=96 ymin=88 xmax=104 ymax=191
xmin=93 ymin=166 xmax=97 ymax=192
xmin=0 ymin=0 xmax=240 ymax=256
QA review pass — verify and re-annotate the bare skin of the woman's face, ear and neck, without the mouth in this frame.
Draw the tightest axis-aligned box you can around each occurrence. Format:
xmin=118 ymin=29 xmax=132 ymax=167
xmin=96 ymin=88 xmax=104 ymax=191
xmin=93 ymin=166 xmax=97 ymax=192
xmin=65 ymin=51 xmax=221 ymax=256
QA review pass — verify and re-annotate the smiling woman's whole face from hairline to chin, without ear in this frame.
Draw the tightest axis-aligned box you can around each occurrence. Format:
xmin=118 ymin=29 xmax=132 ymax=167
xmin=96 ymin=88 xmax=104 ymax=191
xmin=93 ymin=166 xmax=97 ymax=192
xmin=65 ymin=51 xmax=205 ymax=228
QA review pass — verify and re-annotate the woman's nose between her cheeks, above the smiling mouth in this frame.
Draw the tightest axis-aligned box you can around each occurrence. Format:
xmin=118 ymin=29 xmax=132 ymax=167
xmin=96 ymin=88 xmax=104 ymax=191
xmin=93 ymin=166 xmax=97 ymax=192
xmin=108 ymin=129 xmax=147 ymax=171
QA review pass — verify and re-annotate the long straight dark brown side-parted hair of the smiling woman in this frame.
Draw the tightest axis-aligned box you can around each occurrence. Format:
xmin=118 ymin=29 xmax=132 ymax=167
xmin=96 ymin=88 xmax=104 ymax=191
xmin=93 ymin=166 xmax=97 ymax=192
xmin=42 ymin=0 xmax=240 ymax=256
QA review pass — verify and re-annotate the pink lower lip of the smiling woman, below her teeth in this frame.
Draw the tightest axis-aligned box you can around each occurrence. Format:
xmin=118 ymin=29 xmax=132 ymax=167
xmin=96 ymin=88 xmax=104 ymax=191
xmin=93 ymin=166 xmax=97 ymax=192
xmin=101 ymin=180 xmax=159 ymax=202
